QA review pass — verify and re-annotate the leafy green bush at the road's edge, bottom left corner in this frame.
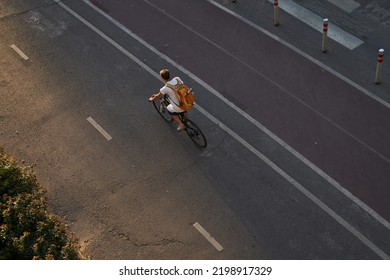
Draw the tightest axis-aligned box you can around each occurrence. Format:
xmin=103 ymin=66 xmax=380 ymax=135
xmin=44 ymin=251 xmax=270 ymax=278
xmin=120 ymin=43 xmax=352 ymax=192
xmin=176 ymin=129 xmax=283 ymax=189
xmin=0 ymin=148 xmax=79 ymax=260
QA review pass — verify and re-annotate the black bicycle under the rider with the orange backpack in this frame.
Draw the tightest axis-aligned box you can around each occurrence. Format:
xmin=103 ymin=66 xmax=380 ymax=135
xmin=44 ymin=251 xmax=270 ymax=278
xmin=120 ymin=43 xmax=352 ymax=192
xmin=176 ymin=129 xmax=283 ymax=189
xmin=152 ymin=96 xmax=207 ymax=148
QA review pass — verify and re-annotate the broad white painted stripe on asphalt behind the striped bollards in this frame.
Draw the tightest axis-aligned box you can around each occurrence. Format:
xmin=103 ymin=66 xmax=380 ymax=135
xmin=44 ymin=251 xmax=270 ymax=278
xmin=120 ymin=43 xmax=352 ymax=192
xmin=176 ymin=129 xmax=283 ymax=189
xmin=268 ymin=0 xmax=364 ymax=50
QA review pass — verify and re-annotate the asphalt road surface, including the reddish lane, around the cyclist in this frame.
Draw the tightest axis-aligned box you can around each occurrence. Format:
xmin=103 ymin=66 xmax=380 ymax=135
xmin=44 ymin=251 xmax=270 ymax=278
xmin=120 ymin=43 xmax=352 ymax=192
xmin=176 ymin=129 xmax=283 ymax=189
xmin=0 ymin=0 xmax=390 ymax=259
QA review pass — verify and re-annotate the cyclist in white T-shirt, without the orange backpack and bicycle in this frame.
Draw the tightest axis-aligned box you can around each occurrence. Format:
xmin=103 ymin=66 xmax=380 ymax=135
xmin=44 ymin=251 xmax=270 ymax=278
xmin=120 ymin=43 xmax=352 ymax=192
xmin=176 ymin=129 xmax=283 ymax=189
xmin=149 ymin=69 xmax=187 ymax=131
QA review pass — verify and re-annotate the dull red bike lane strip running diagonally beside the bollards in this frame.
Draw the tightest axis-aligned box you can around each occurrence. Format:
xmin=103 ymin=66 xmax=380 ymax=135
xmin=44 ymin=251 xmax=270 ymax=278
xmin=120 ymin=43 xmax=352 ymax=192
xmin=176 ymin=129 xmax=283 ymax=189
xmin=91 ymin=0 xmax=390 ymax=220
